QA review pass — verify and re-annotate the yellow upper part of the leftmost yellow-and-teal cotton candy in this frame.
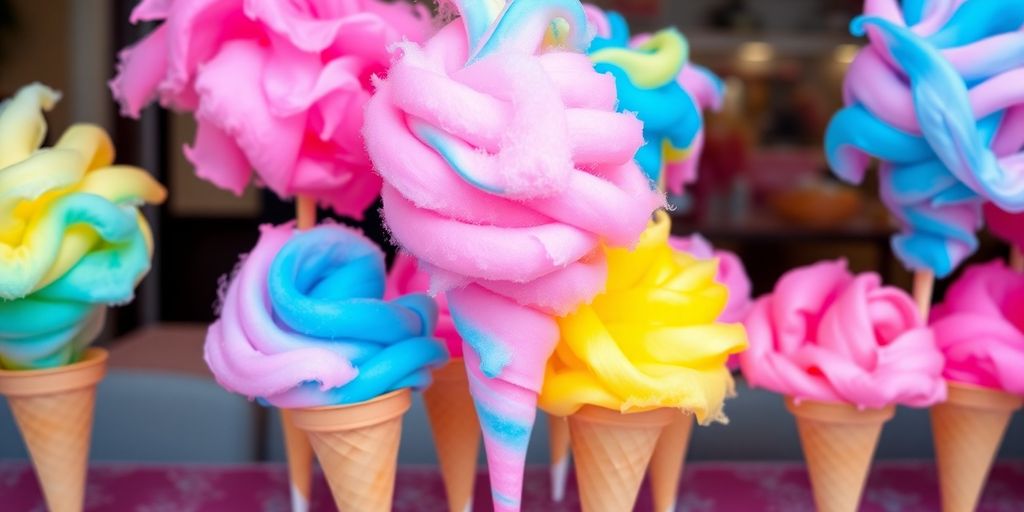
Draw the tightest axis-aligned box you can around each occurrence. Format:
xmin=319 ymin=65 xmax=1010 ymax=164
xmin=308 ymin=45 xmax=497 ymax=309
xmin=0 ymin=84 xmax=166 ymax=299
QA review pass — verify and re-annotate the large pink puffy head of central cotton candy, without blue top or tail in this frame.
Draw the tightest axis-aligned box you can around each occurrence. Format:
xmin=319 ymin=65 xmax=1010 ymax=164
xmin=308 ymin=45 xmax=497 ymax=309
xmin=365 ymin=25 xmax=659 ymax=312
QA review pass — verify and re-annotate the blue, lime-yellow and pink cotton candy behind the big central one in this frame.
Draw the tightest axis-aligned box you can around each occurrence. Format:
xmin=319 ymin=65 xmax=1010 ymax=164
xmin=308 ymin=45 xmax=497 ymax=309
xmin=585 ymin=5 xmax=724 ymax=194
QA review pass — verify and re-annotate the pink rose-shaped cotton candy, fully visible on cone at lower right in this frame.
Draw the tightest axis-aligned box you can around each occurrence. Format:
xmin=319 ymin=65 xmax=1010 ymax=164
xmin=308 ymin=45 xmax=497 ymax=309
xmin=739 ymin=261 xmax=946 ymax=409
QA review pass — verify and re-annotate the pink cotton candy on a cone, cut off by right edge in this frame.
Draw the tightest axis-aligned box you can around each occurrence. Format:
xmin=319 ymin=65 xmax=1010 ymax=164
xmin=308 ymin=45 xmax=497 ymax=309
xmin=932 ymin=261 xmax=1024 ymax=395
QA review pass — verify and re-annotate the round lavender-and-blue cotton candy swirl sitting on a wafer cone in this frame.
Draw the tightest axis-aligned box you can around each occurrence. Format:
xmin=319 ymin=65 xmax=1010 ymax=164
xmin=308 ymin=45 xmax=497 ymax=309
xmin=206 ymin=224 xmax=447 ymax=408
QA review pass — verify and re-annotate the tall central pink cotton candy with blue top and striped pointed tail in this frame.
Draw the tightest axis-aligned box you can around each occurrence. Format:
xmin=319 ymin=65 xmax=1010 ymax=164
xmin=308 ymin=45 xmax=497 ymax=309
xmin=365 ymin=0 xmax=659 ymax=510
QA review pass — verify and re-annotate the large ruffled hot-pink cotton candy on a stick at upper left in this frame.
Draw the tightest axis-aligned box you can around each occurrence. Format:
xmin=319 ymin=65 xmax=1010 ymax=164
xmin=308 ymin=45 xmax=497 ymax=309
xmin=111 ymin=0 xmax=431 ymax=217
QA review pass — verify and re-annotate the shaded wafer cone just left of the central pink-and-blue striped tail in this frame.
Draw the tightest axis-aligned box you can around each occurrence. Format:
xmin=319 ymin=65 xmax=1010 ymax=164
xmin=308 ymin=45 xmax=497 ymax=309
xmin=423 ymin=358 xmax=480 ymax=512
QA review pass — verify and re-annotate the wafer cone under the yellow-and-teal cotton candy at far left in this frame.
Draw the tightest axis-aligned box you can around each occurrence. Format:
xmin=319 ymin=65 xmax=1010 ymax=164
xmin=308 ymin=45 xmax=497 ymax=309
xmin=0 ymin=348 xmax=108 ymax=512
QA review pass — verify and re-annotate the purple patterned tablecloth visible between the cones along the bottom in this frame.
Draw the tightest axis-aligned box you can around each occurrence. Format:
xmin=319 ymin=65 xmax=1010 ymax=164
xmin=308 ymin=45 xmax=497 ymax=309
xmin=0 ymin=461 xmax=1024 ymax=512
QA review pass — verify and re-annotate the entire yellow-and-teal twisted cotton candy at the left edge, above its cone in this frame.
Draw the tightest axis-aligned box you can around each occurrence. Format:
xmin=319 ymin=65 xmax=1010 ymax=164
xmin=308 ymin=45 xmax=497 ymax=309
xmin=0 ymin=84 xmax=165 ymax=370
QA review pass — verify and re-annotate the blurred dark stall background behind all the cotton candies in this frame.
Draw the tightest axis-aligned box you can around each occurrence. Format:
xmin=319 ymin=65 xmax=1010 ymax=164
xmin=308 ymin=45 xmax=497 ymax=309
xmin=0 ymin=0 xmax=1024 ymax=463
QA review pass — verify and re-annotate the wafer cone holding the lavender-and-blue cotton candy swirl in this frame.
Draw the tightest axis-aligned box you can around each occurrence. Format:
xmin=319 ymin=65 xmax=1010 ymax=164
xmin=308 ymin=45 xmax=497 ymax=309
xmin=289 ymin=389 xmax=412 ymax=512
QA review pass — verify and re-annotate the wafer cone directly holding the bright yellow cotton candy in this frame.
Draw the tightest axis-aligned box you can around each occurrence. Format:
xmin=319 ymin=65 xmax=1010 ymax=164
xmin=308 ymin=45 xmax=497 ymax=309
xmin=568 ymin=406 xmax=678 ymax=512
